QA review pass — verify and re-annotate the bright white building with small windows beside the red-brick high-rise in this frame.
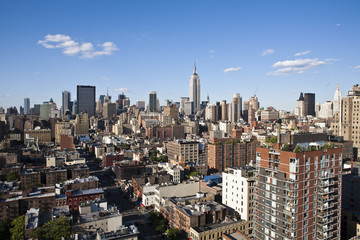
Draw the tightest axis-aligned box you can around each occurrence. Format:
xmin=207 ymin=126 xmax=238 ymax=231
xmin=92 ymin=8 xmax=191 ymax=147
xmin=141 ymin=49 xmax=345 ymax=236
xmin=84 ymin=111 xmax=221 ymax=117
xmin=222 ymin=166 xmax=255 ymax=221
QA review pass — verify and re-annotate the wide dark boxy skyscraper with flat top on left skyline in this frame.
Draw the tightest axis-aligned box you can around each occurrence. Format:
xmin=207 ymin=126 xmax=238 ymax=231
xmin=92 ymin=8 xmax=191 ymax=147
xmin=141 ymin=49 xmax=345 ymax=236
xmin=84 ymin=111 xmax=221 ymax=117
xmin=77 ymin=85 xmax=96 ymax=117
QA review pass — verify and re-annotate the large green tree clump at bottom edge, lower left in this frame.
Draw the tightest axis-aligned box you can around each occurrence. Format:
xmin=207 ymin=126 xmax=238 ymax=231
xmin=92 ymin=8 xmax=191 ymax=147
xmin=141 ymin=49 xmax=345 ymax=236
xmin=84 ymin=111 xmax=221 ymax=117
xmin=31 ymin=217 xmax=71 ymax=240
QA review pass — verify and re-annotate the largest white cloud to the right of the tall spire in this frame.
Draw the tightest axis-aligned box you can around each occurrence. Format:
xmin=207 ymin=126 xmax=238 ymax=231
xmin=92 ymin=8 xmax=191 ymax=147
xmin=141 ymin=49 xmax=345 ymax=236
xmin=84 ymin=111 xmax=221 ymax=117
xmin=268 ymin=58 xmax=326 ymax=76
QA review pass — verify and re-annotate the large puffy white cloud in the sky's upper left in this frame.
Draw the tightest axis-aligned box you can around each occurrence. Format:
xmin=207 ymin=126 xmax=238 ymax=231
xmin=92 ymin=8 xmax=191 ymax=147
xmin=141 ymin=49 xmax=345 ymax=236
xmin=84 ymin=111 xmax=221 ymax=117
xmin=38 ymin=34 xmax=118 ymax=58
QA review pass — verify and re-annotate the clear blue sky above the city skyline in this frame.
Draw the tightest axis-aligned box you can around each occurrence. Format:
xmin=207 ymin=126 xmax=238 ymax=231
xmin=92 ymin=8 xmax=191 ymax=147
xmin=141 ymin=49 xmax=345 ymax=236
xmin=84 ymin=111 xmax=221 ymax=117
xmin=0 ymin=0 xmax=360 ymax=110
